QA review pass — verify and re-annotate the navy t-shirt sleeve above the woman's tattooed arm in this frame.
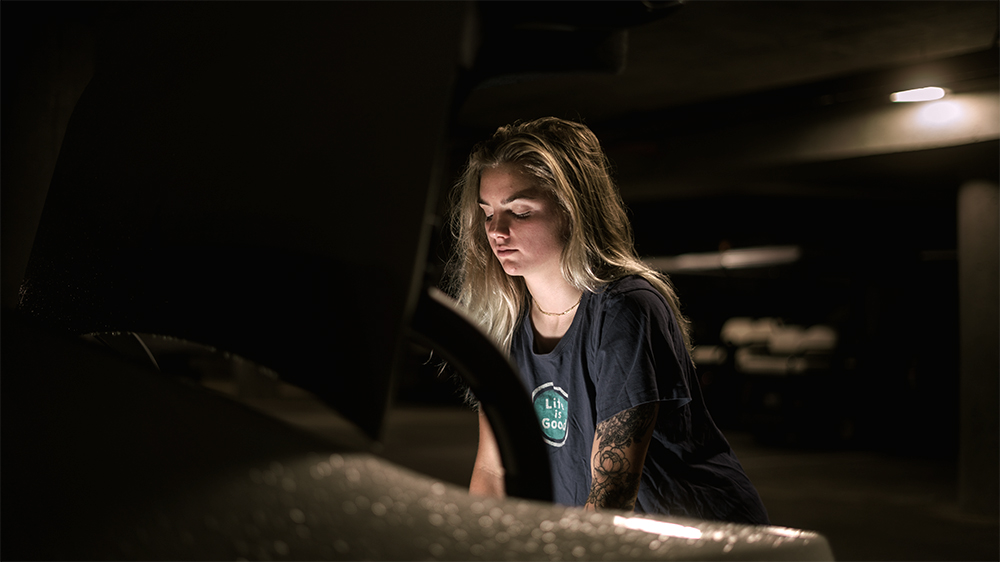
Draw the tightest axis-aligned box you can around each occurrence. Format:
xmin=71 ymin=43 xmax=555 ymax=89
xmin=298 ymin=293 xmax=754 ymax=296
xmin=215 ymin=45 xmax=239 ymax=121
xmin=594 ymin=288 xmax=691 ymax=422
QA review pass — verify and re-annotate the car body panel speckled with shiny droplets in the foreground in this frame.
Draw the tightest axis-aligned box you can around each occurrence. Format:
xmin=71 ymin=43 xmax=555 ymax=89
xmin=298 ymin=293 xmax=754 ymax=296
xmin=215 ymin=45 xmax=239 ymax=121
xmin=0 ymin=314 xmax=832 ymax=560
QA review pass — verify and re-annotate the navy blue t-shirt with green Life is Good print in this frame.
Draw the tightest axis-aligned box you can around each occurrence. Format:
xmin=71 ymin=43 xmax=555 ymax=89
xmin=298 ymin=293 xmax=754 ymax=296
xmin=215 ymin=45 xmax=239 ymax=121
xmin=511 ymin=276 xmax=768 ymax=524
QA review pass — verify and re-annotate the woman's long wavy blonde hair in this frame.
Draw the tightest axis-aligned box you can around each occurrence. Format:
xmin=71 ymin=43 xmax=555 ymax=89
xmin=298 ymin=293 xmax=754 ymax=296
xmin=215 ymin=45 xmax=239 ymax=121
xmin=445 ymin=117 xmax=691 ymax=353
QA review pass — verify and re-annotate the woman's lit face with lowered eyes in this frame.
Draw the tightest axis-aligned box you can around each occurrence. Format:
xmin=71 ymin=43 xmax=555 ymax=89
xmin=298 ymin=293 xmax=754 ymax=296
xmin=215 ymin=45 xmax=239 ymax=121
xmin=479 ymin=164 xmax=565 ymax=276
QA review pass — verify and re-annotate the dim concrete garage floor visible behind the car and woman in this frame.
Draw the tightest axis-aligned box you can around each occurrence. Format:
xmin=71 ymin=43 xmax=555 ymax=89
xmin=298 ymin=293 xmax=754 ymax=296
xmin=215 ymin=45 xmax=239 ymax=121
xmin=230 ymin=382 xmax=1000 ymax=560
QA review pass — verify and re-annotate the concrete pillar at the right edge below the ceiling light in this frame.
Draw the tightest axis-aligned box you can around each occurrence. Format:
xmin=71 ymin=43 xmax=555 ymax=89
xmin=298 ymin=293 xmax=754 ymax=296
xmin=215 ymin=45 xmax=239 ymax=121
xmin=958 ymin=181 xmax=1000 ymax=515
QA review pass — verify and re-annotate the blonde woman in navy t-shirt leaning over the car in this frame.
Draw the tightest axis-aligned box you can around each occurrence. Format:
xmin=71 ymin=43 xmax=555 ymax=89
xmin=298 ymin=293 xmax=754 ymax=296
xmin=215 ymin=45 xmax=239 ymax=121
xmin=450 ymin=117 xmax=767 ymax=524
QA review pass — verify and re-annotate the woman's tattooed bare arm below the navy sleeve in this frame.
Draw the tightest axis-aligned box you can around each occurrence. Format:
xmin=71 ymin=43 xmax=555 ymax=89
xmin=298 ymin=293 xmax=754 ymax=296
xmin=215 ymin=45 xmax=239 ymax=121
xmin=585 ymin=402 xmax=659 ymax=510
